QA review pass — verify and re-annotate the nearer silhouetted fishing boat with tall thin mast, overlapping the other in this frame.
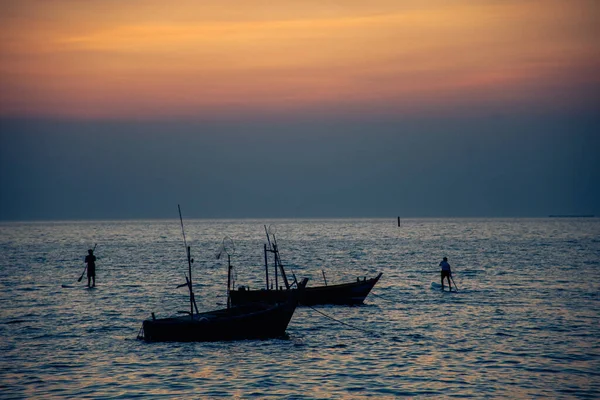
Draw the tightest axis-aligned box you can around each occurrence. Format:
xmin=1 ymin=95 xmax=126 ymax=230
xmin=138 ymin=208 xmax=308 ymax=342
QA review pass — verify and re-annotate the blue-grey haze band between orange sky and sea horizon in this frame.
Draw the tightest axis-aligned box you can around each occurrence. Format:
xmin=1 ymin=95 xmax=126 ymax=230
xmin=0 ymin=117 xmax=600 ymax=220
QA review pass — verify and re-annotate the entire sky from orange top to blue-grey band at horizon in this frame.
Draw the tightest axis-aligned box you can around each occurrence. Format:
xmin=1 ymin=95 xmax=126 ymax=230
xmin=0 ymin=0 xmax=600 ymax=220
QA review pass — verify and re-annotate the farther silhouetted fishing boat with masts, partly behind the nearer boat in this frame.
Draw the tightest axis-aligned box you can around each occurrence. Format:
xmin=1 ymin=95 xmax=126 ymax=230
xmin=230 ymin=227 xmax=382 ymax=306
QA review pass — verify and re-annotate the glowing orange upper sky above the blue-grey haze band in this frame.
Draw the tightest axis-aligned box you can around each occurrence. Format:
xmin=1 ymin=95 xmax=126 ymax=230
xmin=0 ymin=0 xmax=600 ymax=119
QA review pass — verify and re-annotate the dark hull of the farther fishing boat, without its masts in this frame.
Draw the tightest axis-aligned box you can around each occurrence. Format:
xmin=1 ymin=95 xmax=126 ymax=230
xmin=230 ymin=273 xmax=382 ymax=306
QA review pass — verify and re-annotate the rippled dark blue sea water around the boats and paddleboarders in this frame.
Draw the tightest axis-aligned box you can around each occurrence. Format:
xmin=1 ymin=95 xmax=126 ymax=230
xmin=0 ymin=218 xmax=600 ymax=399
